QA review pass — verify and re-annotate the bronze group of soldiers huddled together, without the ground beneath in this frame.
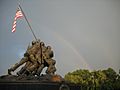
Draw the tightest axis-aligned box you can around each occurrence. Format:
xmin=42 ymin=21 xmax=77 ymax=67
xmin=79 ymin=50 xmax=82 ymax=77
xmin=8 ymin=40 xmax=56 ymax=76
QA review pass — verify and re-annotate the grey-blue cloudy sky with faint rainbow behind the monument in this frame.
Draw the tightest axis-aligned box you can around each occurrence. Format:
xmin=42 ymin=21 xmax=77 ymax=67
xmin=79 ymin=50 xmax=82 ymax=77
xmin=0 ymin=0 xmax=120 ymax=76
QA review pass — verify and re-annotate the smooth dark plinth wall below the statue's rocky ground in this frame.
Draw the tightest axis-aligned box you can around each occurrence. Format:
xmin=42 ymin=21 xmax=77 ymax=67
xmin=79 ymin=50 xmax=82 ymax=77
xmin=0 ymin=82 xmax=80 ymax=90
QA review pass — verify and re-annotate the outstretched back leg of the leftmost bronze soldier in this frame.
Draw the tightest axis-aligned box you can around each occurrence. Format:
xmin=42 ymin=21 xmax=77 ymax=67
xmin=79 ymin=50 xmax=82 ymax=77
xmin=8 ymin=57 xmax=28 ymax=74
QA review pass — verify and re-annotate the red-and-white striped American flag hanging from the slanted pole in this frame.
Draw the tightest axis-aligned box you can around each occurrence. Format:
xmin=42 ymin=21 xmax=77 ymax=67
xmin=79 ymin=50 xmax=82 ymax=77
xmin=12 ymin=9 xmax=23 ymax=32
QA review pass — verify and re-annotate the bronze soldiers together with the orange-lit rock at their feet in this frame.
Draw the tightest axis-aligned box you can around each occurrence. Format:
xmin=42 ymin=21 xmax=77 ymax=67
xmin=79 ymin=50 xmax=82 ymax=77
xmin=2 ymin=39 xmax=63 ymax=82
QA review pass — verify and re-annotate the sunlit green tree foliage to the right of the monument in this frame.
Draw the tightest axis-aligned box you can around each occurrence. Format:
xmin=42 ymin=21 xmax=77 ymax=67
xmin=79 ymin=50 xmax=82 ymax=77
xmin=64 ymin=68 xmax=120 ymax=90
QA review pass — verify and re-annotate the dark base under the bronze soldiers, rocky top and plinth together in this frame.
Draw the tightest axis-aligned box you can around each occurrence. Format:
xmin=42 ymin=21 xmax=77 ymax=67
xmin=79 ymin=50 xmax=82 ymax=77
xmin=0 ymin=75 xmax=80 ymax=90
